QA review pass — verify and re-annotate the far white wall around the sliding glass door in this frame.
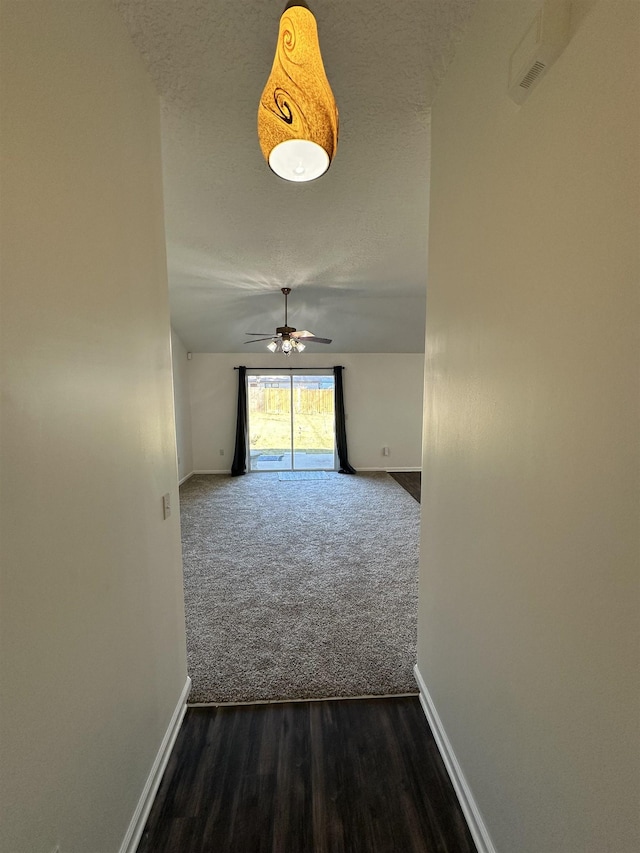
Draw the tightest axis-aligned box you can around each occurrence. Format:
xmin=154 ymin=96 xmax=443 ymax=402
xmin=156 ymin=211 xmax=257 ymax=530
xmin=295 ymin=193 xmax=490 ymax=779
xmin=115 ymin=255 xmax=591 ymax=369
xmin=189 ymin=351 xmax=424 ymax=471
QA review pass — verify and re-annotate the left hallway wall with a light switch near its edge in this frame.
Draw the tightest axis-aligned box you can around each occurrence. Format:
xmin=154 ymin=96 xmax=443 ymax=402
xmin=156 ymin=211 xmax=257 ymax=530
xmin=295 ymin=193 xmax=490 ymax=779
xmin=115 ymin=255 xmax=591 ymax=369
xmin=0 ymin=0 xmax=186 ymax=853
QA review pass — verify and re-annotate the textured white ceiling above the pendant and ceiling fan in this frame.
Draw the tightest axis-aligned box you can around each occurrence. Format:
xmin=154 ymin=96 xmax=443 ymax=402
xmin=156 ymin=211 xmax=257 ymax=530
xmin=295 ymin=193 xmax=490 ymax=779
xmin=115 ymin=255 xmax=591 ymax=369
xmin=114 ymin=0 xmax=475 ymax=358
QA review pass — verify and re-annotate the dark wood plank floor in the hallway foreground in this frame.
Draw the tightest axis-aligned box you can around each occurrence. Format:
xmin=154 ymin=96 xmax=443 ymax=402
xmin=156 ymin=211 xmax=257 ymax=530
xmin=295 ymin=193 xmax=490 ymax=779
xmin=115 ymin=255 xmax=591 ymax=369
xmin=138 ymin=697 xmax=476 ymax=853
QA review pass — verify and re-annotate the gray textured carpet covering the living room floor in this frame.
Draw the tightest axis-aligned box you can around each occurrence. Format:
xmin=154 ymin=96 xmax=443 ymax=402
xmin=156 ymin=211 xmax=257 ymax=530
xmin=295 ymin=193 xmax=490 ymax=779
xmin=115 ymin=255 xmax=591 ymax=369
xmin=180 ymin=472 xmax=420 ymax=703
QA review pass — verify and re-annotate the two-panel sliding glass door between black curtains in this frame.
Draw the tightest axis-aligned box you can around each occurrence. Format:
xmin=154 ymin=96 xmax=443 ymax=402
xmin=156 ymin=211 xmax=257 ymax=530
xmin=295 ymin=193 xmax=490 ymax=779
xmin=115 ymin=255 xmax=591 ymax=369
xmin=247 ymin=370 xmax=336 ymax=471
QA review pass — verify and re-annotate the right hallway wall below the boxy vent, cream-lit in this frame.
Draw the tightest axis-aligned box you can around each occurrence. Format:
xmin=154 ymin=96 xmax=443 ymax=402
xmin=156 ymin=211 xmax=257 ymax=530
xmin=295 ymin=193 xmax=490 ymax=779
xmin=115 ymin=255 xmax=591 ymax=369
xmin=418 ymin=0 xmax=640 ymax=853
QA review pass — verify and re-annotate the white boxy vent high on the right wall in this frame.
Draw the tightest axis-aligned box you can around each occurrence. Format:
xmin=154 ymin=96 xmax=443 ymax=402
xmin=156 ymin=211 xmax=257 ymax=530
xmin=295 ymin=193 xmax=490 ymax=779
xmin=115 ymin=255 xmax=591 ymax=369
xmin=509 ymin=0 xmax=570 ymax=104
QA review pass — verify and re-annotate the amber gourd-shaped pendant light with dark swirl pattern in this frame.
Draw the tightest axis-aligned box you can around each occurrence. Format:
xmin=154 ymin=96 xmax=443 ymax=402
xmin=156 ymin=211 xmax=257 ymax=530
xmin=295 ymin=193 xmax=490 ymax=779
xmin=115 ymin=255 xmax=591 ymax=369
xmin=258 ymin=0 xmax=338 ymax=181
